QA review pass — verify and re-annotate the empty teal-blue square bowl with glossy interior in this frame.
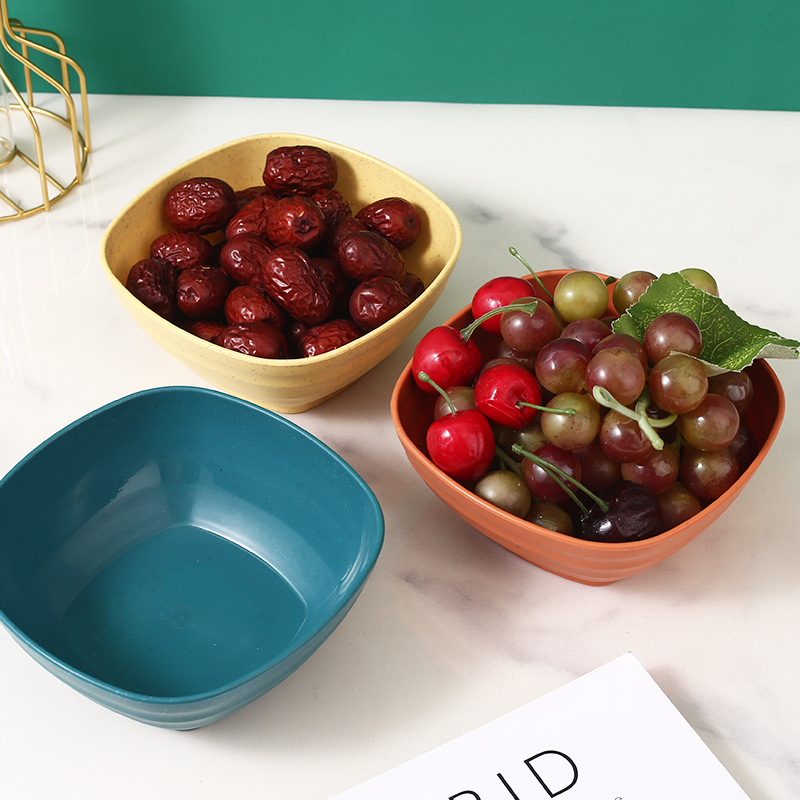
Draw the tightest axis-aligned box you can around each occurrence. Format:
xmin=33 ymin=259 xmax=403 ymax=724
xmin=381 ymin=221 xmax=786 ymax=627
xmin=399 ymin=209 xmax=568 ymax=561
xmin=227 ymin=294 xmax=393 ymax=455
xmin=0 ymin=387 xmax=384 ymax=730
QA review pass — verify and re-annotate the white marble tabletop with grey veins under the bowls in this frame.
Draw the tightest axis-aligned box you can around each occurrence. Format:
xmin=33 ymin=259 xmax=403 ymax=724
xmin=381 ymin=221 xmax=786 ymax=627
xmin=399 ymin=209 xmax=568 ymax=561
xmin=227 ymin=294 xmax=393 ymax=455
xmin=0 ymin=96 xmax=800 ymax=800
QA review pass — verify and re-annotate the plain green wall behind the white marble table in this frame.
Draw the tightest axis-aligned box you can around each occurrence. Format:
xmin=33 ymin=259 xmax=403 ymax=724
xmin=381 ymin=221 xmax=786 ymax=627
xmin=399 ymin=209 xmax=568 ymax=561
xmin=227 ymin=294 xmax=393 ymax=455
xmin=8 ymin=0 xmax=800 ymax=110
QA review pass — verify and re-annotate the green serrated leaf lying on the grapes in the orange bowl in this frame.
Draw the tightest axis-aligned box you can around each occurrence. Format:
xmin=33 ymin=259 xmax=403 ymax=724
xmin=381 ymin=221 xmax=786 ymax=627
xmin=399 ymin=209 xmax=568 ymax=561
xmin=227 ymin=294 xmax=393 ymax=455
xmin=612 ymin=272 xmax=800 ymax=374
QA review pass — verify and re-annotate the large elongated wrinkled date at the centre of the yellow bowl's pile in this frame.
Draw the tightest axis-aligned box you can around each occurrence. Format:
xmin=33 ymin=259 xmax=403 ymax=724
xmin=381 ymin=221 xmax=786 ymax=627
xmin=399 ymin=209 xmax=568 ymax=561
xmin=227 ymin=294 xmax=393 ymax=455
xmin=259 ymin=245 xmax=333 ymax=326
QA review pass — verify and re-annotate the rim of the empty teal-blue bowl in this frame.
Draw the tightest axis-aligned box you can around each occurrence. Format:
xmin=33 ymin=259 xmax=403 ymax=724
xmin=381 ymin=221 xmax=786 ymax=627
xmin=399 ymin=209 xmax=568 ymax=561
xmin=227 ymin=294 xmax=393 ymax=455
xmin=0 ymin=386 xmax=385 ymax=707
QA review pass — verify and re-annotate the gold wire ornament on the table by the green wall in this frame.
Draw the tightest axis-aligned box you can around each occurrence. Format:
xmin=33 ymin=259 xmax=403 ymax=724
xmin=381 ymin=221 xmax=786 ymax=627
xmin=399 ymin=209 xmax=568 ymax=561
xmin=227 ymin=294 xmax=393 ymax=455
xmin=0 ymin=0 xmax=91 ymax=222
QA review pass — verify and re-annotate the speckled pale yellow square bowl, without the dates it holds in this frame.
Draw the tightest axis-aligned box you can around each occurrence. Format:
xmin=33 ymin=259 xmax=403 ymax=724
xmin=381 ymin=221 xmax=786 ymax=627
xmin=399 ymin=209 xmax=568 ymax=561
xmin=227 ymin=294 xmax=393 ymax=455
xmin=100 ymin=133 xmax=461 ymax=413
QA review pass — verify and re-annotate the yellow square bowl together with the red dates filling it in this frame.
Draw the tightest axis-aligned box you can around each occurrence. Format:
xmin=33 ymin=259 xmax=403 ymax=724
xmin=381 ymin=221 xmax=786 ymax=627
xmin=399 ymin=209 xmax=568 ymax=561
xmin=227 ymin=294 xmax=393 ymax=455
xmin=101 ymin=134 xmax=461 ymax=413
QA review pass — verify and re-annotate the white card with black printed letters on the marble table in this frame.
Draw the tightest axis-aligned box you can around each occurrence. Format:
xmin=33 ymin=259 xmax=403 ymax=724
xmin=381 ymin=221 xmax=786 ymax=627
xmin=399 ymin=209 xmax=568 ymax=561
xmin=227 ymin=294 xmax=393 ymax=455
xmin=331 ymin=653 xmax=747 ymax=800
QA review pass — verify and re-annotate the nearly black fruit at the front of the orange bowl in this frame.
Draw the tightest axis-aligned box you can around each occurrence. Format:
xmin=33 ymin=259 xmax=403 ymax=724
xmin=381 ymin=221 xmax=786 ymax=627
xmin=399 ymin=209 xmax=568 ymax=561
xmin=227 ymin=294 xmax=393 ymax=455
xmin=580 ymin=480 xmax=663 ymax=542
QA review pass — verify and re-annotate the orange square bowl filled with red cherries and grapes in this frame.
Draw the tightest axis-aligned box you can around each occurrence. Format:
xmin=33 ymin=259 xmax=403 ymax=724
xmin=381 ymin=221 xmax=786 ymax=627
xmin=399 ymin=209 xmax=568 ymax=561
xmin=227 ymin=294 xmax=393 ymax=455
xmin=391 ymin=270 xmax=800 ymax=585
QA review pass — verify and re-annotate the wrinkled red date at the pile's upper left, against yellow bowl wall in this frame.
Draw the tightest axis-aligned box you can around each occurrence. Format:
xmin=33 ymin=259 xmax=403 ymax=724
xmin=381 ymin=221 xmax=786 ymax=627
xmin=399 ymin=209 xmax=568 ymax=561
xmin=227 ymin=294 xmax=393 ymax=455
xmin=164 ymin=178 xmax=237 ymax=233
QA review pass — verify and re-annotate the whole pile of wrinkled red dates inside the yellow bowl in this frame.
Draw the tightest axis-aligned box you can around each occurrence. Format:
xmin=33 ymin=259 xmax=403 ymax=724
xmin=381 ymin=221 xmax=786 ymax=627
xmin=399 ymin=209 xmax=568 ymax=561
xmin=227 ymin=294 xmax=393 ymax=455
xmin=126 ymin=144 xmax=424 ymax=358
